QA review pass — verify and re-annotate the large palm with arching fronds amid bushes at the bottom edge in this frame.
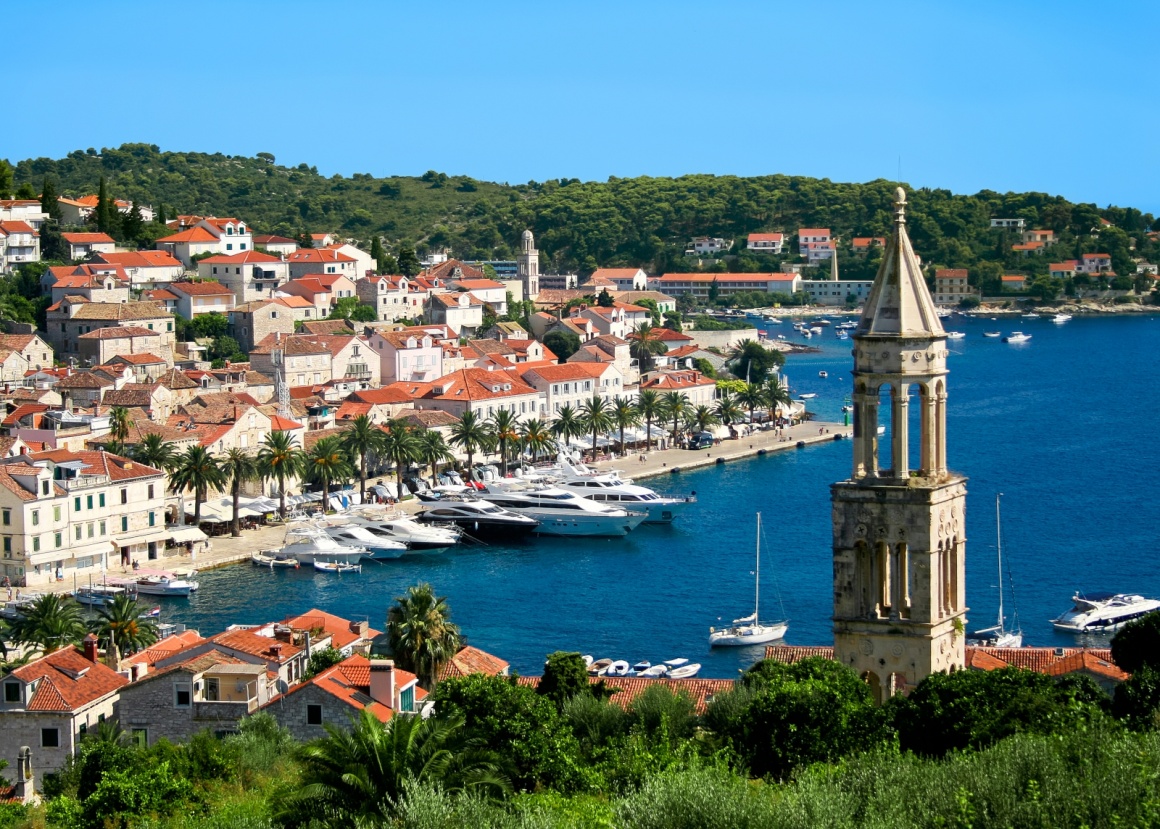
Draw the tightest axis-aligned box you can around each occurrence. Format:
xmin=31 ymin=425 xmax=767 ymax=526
xmin=277 ymin=707 xmax=510 ymax=827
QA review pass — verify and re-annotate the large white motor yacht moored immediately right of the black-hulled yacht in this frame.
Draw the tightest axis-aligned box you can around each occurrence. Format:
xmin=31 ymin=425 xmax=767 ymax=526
xmin=479 ymin=479 xmax=648 ymax=536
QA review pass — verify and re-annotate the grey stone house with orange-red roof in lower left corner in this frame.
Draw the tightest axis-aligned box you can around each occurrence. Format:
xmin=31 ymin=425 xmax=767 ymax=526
xmin=0 ymin=633 xmax=129 ymax=775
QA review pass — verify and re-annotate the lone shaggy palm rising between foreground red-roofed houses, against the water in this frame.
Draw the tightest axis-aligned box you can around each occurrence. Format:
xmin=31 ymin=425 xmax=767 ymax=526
xmin=386 ymin=584 xmax=461 ymax=691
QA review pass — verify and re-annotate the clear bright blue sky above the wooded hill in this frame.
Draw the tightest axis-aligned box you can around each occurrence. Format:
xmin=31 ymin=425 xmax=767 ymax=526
xmin=11 ymin=0 xmax=1160 ymax=212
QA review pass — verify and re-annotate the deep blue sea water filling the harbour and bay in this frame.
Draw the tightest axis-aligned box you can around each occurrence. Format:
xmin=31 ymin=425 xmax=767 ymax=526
xmin=164 ymin=318 xmax=1160 ymax=677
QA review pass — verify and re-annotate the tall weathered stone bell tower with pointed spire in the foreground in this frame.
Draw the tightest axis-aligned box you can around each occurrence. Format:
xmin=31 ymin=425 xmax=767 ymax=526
xmin=831 ymin=188 xmax=966 ymax=701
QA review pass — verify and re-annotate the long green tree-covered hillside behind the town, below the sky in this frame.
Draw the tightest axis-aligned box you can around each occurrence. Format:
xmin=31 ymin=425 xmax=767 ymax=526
xmin=4 ymin=144 xmax=1155 ymax=289
